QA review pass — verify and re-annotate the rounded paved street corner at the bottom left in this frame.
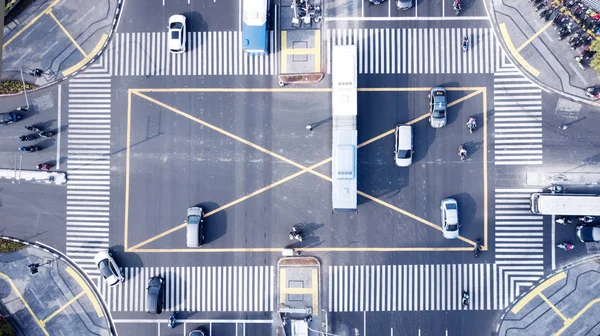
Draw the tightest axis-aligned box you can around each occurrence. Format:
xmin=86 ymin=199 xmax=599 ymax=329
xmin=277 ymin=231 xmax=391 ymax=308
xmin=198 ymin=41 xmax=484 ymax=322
xmin=0 ymin=238 xmax=112 ymax=335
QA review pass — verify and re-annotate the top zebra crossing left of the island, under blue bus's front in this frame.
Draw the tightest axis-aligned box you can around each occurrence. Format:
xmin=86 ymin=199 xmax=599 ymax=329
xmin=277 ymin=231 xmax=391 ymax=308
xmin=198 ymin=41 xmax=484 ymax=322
xmin=102 ymin=31 xmax=278 ymax=76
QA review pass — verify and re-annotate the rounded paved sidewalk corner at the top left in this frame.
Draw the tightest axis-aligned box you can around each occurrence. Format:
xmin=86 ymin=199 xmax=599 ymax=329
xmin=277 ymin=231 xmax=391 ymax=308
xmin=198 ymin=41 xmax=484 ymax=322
xmin=1 ymin=0 xmax=122 ymax=87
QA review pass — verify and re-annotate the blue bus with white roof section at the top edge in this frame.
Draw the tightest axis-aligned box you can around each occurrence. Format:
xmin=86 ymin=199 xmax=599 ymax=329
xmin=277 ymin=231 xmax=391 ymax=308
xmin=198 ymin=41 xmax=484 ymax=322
xmin=242 ymin=0 xmax=269 ymax=56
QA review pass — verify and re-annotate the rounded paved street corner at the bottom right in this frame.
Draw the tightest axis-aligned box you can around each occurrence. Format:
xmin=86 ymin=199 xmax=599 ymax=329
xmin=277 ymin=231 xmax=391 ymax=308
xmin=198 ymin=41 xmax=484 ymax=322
xmin=497 ymin=258 xmax=600 ymax=336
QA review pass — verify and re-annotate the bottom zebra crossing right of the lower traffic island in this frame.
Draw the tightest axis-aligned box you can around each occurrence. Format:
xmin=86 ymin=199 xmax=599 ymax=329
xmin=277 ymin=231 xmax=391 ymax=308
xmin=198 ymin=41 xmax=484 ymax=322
xmin=327 ymin=264 xmax=502 ymax=312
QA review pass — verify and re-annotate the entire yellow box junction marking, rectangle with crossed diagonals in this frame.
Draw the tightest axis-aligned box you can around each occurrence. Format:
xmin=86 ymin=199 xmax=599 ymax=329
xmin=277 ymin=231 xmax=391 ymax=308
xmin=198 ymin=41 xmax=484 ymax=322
xmin=124 ymin=87 xmax=488 ymax=252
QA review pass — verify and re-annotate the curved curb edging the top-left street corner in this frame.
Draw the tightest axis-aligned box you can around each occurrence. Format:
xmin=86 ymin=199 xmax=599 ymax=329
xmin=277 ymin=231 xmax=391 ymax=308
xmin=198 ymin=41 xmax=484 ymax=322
xmin=0 ymin=0 xmax=125 ymax=98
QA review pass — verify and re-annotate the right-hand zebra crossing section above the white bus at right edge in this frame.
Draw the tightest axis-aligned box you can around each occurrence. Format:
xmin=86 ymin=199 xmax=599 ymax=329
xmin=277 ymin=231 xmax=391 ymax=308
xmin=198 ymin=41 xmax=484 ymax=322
xmin=493 ymin=64 xmax=543 ymax=165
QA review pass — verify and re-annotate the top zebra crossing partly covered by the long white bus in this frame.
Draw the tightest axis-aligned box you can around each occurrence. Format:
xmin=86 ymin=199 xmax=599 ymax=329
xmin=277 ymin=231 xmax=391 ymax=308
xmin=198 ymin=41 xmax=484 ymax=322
xmin=327 ymin=28 xmax=501 ymax=74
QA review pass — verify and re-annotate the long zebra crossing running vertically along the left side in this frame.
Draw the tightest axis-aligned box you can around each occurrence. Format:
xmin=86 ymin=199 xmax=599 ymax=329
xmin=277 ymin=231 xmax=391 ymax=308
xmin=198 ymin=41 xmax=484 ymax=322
xmin=66 ymin=63 xmax=111 ymax=275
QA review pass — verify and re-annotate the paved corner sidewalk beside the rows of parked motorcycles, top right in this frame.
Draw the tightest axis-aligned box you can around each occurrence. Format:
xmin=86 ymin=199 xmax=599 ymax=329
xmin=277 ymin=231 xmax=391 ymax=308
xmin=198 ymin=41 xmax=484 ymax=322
xmin=484 ymin=0 xmax=600 ymax=106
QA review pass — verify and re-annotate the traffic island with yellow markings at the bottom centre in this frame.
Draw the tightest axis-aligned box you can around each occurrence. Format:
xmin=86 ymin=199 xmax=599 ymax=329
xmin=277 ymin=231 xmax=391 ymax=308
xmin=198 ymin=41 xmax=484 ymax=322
xmin=277 ymin=256 xmax=327 ymax=336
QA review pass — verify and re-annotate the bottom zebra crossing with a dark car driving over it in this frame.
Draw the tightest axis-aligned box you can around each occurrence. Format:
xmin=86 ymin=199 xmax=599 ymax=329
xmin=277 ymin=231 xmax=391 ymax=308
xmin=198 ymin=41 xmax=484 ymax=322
xmin=99 ymin=266 xmax=275 ymax=312
